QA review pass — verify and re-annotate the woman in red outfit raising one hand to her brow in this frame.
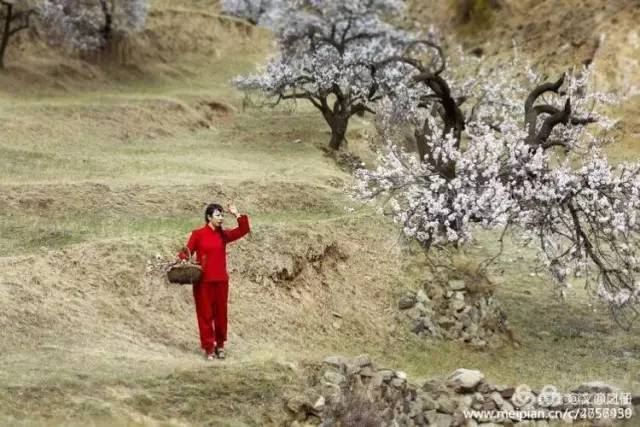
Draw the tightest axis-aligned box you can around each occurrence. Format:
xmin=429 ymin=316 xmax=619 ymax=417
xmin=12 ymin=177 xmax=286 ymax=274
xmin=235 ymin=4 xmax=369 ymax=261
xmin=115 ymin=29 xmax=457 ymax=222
xmin=178 ymin=203 xmax=249 ymax=360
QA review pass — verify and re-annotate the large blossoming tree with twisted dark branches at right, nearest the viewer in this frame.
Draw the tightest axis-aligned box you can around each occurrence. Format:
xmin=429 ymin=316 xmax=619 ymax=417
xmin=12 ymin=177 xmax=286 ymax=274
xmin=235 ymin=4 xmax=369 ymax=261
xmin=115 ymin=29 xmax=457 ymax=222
xmin=355 ymin=46 xmax=640 ymax=328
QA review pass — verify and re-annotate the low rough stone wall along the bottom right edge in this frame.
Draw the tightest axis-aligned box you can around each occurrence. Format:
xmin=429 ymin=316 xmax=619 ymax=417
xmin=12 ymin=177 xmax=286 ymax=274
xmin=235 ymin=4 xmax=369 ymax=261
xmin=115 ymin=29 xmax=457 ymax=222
xmin=286 ymin=355 xmax=640 ymax=427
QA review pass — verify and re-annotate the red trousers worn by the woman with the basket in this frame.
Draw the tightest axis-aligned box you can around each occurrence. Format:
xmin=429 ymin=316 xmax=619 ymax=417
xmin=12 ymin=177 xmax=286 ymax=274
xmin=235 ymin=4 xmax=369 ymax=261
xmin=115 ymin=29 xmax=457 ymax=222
xmin=193 ymin=280 xmax=229 ymax=352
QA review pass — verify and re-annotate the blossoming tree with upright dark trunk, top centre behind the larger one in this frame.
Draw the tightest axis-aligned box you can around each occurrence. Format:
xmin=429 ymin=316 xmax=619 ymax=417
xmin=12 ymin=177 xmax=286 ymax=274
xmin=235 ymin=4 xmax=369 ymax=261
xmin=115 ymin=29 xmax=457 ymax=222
xmin=234 ymin=0 xmax=412 ymax=149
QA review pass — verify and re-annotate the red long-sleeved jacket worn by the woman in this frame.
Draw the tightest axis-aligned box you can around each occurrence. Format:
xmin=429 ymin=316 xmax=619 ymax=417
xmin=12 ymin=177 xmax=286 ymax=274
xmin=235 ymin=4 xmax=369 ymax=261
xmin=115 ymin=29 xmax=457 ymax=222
xmin=178 ymin=215 xmax=250 ymax=282
